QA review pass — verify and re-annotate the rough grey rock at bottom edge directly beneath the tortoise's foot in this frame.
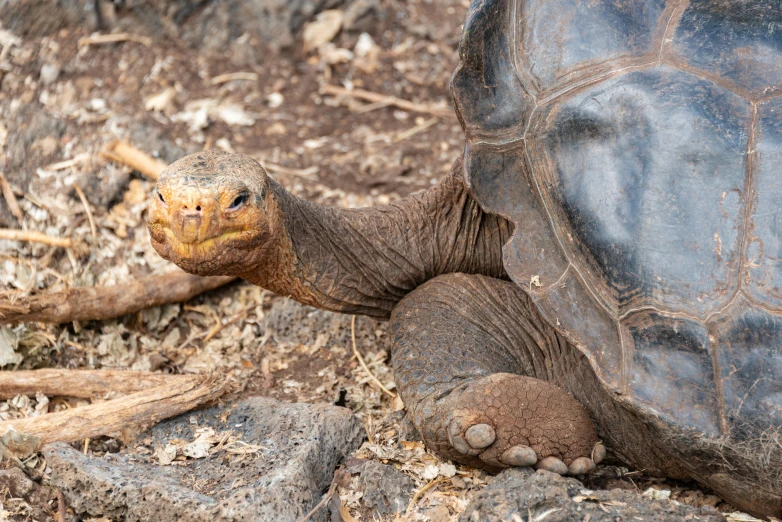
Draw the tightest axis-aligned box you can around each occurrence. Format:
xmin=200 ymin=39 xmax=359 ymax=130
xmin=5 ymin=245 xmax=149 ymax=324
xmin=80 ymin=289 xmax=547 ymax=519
xmin=459 ymin=468 xmax=725 ymax=522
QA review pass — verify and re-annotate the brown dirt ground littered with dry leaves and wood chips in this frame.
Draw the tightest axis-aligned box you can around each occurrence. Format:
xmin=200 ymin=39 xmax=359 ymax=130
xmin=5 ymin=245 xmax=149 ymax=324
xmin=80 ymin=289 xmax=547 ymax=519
xmin=0 ymin=0 xmax=764 ymax=521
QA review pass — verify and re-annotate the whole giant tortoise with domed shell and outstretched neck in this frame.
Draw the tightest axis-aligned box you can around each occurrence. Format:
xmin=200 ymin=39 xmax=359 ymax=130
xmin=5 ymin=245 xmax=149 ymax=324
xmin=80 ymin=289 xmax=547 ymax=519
xmin=149 ymin=0 xmax=782 ymax=516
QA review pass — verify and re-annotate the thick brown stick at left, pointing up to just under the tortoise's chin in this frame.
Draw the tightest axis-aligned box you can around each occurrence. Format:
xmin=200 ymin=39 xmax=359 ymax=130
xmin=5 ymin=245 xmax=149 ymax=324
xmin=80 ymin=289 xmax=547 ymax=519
xmin=0 ymin=271 xmax=236 ymax=324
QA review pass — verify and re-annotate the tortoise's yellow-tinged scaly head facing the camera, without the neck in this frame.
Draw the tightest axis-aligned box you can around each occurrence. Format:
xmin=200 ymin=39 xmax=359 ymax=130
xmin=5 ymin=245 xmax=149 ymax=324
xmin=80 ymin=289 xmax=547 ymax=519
xmin=147 ymin=151 xmax=273 ymax=275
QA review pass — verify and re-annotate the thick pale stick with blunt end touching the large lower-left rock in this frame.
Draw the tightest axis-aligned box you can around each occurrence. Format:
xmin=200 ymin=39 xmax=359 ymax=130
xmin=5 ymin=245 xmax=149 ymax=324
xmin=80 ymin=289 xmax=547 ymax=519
xmin=0 ymin=375 xmax=225 ymax=452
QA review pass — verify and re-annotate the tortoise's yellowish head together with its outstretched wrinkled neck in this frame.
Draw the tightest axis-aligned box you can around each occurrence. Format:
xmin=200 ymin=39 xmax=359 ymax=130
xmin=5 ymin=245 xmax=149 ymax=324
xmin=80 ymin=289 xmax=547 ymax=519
xmin=148 ymin=151 xmax=512 ymax=318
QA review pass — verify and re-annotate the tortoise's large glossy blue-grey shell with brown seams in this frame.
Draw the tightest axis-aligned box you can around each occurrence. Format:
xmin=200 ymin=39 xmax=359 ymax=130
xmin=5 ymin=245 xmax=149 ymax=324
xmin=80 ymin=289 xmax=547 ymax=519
xmin=452 ymin=0 xmax=782 ymax=439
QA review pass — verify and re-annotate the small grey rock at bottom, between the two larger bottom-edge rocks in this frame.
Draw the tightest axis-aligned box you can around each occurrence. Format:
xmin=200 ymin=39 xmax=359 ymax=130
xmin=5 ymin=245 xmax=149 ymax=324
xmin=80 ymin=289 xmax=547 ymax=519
xmin=358 ymin=460 xmax=415 ymax=520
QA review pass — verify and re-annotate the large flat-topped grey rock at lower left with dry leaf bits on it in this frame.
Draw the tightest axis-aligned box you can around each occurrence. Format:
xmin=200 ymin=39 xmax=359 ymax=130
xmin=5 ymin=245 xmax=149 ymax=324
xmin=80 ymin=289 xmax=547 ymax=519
xmin=43 ymin=398 xmax=364 ymax=522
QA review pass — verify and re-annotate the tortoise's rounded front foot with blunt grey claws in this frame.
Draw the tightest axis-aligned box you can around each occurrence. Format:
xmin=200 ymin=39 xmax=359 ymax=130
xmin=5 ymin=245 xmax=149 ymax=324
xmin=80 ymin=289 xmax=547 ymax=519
xmin=439 ymin=373 xmax=605 ymax=475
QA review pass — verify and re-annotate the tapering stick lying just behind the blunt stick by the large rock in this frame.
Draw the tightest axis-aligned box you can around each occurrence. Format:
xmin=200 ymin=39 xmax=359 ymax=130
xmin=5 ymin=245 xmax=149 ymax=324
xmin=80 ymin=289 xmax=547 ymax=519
xmin=0 ymin=368 xmax=196 ymax=400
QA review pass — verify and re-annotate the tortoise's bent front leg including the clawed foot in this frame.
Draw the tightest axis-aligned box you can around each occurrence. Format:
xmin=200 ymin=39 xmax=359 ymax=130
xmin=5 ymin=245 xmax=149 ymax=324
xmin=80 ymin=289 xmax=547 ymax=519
xmin=392 ymin=274 xmax=605 ymax=475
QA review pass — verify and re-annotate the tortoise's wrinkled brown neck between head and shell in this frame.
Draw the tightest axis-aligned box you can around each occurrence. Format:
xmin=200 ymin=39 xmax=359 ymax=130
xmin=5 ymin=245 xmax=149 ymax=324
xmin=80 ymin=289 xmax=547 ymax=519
xmin=244 ymin=162 xmax=512 ymax=318
